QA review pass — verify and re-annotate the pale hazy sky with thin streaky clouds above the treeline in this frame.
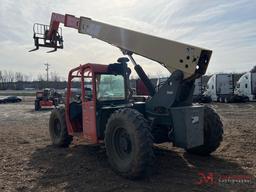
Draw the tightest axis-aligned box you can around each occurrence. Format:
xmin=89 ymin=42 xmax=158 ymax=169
xmin=0 ymin=0 xmax=256 ymax=77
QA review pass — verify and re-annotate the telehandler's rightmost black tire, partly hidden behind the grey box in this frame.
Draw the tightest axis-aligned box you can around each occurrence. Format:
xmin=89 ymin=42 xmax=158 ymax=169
xmin=186 ymin=107 xmax=223 ymax=156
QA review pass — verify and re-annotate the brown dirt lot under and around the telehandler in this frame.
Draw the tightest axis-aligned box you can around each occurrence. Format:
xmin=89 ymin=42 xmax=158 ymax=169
xmin=0 ymin=102 xmax=256 ymax=192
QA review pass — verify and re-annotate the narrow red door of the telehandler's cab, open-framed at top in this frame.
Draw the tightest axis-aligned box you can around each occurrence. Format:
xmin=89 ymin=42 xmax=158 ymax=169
xmin=81 ymin=71 xmax=98 ymax=144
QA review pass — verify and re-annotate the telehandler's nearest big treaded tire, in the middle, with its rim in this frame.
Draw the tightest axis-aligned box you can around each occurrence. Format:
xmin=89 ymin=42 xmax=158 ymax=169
xmin=105 ymin=108 xmax=154 ymax=179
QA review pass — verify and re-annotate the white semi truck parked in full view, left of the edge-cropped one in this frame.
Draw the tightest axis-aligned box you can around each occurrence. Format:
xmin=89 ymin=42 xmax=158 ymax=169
xmin=205 ymin=73 xmax=248 ymax=103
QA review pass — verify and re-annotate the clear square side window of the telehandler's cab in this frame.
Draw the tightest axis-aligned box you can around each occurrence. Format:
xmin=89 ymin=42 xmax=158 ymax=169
xmin=96 ymin=74 xmax=125 ymax=101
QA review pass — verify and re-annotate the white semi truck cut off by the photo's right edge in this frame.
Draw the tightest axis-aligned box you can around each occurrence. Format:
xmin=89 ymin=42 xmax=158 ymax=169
xmin=235 ymin=72 xmax=256 ymax=101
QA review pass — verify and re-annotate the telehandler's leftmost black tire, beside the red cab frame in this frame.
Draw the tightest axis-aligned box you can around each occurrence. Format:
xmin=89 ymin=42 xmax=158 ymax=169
xmin=49 ymin=107 xmax=72 ymax=147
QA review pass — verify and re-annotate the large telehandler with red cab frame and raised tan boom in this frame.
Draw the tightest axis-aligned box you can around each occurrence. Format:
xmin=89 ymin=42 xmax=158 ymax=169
xmin=30 ymin=13 xmax=223 ymax=178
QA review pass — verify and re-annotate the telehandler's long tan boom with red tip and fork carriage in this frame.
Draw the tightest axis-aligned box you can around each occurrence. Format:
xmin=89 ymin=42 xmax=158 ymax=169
xmin=30 ymin=13 xmax=212 ymax=79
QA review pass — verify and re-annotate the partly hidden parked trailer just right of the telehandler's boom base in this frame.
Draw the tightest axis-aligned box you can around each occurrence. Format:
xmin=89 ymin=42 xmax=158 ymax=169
xmin=193 ymin=77 xmax=212 ymax=103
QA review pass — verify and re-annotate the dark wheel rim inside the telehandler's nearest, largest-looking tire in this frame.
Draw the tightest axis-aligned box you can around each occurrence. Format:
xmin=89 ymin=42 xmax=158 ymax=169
xmin=112 ymin=128 xmax=132 ymax=160
